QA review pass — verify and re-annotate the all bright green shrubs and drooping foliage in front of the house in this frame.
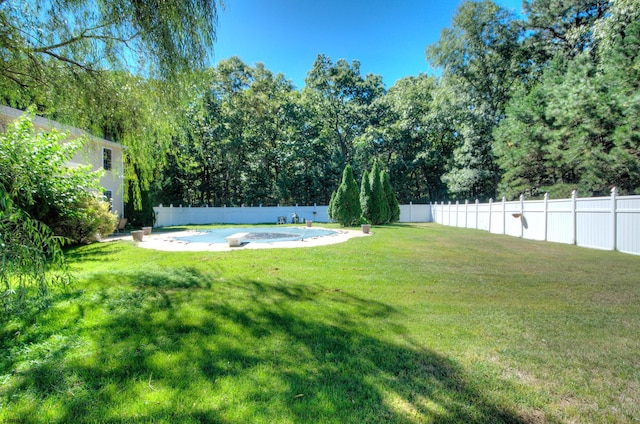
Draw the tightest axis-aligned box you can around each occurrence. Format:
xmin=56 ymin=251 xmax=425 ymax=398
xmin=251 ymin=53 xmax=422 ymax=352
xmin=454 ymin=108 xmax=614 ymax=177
xmin=0 ymin=111 xmax=116 ymax=312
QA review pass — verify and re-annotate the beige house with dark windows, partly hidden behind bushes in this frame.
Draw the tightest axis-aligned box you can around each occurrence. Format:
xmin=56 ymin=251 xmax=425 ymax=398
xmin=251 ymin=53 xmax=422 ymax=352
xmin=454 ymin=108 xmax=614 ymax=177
xmin=0 ymin=106 xmax=125 ymax=216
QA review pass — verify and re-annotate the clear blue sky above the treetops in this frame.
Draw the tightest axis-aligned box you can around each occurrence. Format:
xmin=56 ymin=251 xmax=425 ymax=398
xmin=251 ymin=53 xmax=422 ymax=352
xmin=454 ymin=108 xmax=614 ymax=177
xmin=214 ymin=0 xmax=522 ymax=88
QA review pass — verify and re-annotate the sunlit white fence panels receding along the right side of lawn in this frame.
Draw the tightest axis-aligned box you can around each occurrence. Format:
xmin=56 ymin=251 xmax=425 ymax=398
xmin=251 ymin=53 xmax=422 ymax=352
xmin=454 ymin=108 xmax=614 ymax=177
xmin=431 ymin=188 xmax=640 ymax=255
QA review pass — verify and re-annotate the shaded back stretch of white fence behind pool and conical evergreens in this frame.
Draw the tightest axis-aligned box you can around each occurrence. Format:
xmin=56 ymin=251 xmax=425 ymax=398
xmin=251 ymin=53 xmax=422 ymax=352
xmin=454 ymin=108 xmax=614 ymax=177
xmin=153 ymin=203 xmax=432 ymax=227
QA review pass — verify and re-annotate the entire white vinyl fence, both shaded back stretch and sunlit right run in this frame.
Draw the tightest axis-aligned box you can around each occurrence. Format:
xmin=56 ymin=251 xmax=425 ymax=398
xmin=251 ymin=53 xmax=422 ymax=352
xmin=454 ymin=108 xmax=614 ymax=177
xmin=153 ymin=189 xmax=640 ymax=255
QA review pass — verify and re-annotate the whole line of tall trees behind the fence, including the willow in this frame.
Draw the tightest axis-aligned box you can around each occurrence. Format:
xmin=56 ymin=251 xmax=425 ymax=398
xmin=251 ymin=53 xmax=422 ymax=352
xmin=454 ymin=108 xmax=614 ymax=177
xmin=0 ymin=0 xmax=640 ymax=219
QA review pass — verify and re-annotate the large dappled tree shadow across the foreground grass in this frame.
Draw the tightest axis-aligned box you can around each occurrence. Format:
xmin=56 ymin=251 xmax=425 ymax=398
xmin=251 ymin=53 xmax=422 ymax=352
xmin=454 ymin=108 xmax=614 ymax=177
xmin=0 ymin=268 xmax=520 ymax=423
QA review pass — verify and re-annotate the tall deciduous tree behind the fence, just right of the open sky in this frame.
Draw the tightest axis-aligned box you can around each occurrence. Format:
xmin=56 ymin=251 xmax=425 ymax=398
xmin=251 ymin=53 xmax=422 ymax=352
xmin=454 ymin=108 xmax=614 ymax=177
xmin=427 ymin=0 xmax=523 ymax=198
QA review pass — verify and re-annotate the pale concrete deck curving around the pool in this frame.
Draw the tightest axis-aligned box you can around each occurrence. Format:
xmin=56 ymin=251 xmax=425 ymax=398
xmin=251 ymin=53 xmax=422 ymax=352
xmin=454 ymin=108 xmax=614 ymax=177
xmin=102 ymin=226 xmax=371 ymax=252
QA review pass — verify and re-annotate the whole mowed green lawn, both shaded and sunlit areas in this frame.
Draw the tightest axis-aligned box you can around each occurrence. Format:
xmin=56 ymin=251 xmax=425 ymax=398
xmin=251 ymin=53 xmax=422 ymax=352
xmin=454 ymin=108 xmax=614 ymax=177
xmin=0 ymin=224 xmax=640 ymax=423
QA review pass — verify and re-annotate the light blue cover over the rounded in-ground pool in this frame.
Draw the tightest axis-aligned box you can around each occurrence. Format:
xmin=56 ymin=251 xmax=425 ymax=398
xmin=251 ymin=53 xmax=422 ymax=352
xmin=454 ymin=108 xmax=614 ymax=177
xmin=176 ymin=227 xmax=337 ymax=243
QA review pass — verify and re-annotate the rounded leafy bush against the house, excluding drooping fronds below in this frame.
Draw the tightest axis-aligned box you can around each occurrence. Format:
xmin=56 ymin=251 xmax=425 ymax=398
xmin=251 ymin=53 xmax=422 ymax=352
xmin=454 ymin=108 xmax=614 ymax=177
xmin=0 ymin=112 xmax=116 ymax=243
